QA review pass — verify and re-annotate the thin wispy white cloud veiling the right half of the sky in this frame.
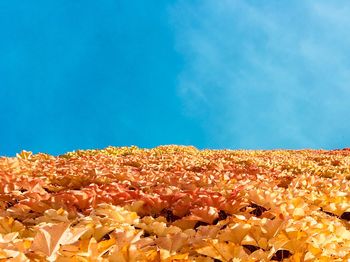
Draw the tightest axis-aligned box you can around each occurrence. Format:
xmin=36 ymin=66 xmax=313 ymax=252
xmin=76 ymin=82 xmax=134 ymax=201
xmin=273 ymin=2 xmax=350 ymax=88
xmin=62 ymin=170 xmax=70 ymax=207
xmin=170 ymin=0 xmax=350 ymax=148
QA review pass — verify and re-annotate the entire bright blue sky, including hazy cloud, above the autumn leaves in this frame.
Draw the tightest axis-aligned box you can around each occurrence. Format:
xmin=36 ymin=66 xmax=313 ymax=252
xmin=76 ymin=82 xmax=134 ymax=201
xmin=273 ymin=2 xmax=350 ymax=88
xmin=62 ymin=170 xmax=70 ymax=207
xmin=0 ymin=0 xmax=350 ymax=156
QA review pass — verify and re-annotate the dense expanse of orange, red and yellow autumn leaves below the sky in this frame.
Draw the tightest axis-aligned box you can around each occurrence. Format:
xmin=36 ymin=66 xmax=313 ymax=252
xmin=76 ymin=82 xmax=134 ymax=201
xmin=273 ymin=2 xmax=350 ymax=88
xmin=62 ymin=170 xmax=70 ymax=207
xmin=0 ymin=146 xmax=350 ymax=262
